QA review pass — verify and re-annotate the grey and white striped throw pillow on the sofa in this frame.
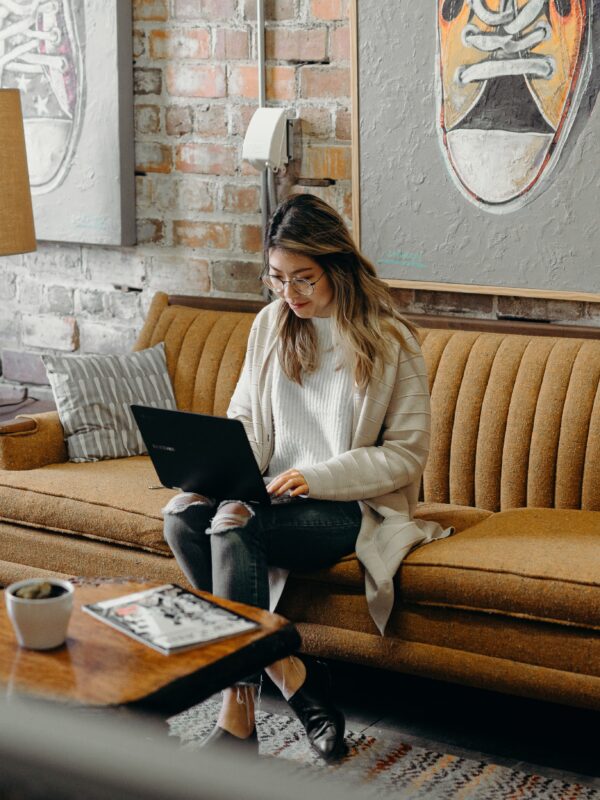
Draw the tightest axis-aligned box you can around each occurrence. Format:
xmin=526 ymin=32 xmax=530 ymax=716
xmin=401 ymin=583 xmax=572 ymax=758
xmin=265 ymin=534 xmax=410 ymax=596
xmin=42 ymin=342 xmax=177 ymax=461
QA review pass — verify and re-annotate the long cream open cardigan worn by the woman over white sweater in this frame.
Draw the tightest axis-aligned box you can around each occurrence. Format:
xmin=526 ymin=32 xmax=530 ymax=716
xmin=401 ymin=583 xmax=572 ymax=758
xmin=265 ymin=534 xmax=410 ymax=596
xmin=227 ymin=300 xmax=452 ymax=634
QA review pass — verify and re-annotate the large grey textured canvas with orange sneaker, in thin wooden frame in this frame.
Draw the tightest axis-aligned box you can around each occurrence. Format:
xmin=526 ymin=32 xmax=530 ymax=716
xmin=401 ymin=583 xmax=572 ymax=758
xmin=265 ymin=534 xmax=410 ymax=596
xmin=352 ymin=0 xmax=600 ymax=301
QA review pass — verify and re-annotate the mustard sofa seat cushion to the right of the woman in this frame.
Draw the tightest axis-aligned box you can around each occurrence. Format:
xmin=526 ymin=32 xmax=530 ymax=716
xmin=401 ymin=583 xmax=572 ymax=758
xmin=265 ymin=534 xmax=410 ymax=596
xmin=398 ymin=508 xmax=600 ymax=629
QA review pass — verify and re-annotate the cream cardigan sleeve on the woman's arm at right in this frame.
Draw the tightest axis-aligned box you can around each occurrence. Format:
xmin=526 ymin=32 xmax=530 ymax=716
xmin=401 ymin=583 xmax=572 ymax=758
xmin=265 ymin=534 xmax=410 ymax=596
xmin=302 ymin=342 xmax=430 ymax=501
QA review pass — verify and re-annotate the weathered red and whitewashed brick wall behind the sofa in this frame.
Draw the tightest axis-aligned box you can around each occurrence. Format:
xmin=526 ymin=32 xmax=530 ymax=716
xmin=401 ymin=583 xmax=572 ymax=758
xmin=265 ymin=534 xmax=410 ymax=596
xmin=0 ymin=0 xmax=596 ymax=394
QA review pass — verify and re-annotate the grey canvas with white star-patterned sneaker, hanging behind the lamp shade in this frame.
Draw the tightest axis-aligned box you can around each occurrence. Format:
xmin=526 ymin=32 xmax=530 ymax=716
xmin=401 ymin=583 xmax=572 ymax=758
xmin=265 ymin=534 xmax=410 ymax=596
xmin=0 ymin=0 xmax=135 ymax=245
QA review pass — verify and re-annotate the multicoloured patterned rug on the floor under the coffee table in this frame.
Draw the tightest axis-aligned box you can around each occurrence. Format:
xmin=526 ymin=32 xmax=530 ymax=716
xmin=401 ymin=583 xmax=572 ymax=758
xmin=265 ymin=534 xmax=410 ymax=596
xmin=169 ymin=696 xmax=600 ymax=800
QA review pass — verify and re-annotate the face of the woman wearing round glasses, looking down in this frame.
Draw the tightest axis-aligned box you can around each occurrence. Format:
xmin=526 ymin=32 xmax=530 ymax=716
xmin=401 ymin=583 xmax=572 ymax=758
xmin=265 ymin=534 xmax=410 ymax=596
xmin=267 ymin=248 xmax=333 ymax=319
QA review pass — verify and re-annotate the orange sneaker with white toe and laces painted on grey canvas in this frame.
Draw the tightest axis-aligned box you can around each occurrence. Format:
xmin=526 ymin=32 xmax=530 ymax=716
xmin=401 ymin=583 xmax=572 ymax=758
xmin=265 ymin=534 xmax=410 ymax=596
xmin=437 ymin=0 xmax=592 ymax=213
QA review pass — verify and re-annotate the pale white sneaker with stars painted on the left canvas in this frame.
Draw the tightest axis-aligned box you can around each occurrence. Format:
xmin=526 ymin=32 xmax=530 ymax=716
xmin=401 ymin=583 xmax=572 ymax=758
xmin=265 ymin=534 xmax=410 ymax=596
xmin=0 ymin=0 xmax=84 ymax=195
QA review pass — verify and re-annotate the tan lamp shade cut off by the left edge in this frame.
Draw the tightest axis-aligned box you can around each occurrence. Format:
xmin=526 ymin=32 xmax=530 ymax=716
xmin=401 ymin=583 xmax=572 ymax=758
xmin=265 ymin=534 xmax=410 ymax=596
xmin=0 ymin=89 xmax=36 ymax=256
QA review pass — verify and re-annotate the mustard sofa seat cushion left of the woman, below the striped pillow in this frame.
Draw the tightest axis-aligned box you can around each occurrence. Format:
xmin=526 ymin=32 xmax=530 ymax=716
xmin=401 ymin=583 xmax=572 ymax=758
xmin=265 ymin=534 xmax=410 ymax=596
xmin=0 ymin=456 xmax=176 ymax=554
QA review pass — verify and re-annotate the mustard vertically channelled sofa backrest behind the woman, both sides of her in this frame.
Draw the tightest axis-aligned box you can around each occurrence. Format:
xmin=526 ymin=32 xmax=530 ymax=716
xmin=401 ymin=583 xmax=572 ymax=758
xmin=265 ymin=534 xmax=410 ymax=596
xmin=135 ymin=294 xmax=600 ymax=511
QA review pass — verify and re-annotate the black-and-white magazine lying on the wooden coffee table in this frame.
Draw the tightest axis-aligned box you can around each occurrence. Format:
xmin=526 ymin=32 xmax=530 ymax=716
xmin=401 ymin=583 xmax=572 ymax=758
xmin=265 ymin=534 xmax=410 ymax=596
xmin=82 ymin=583 xmax=260 ymax=655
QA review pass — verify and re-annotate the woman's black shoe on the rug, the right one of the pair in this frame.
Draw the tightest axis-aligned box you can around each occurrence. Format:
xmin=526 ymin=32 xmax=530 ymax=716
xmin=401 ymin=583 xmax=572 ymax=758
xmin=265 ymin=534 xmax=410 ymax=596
xmin=288 ymin=662 xmax=348 ymax=762
